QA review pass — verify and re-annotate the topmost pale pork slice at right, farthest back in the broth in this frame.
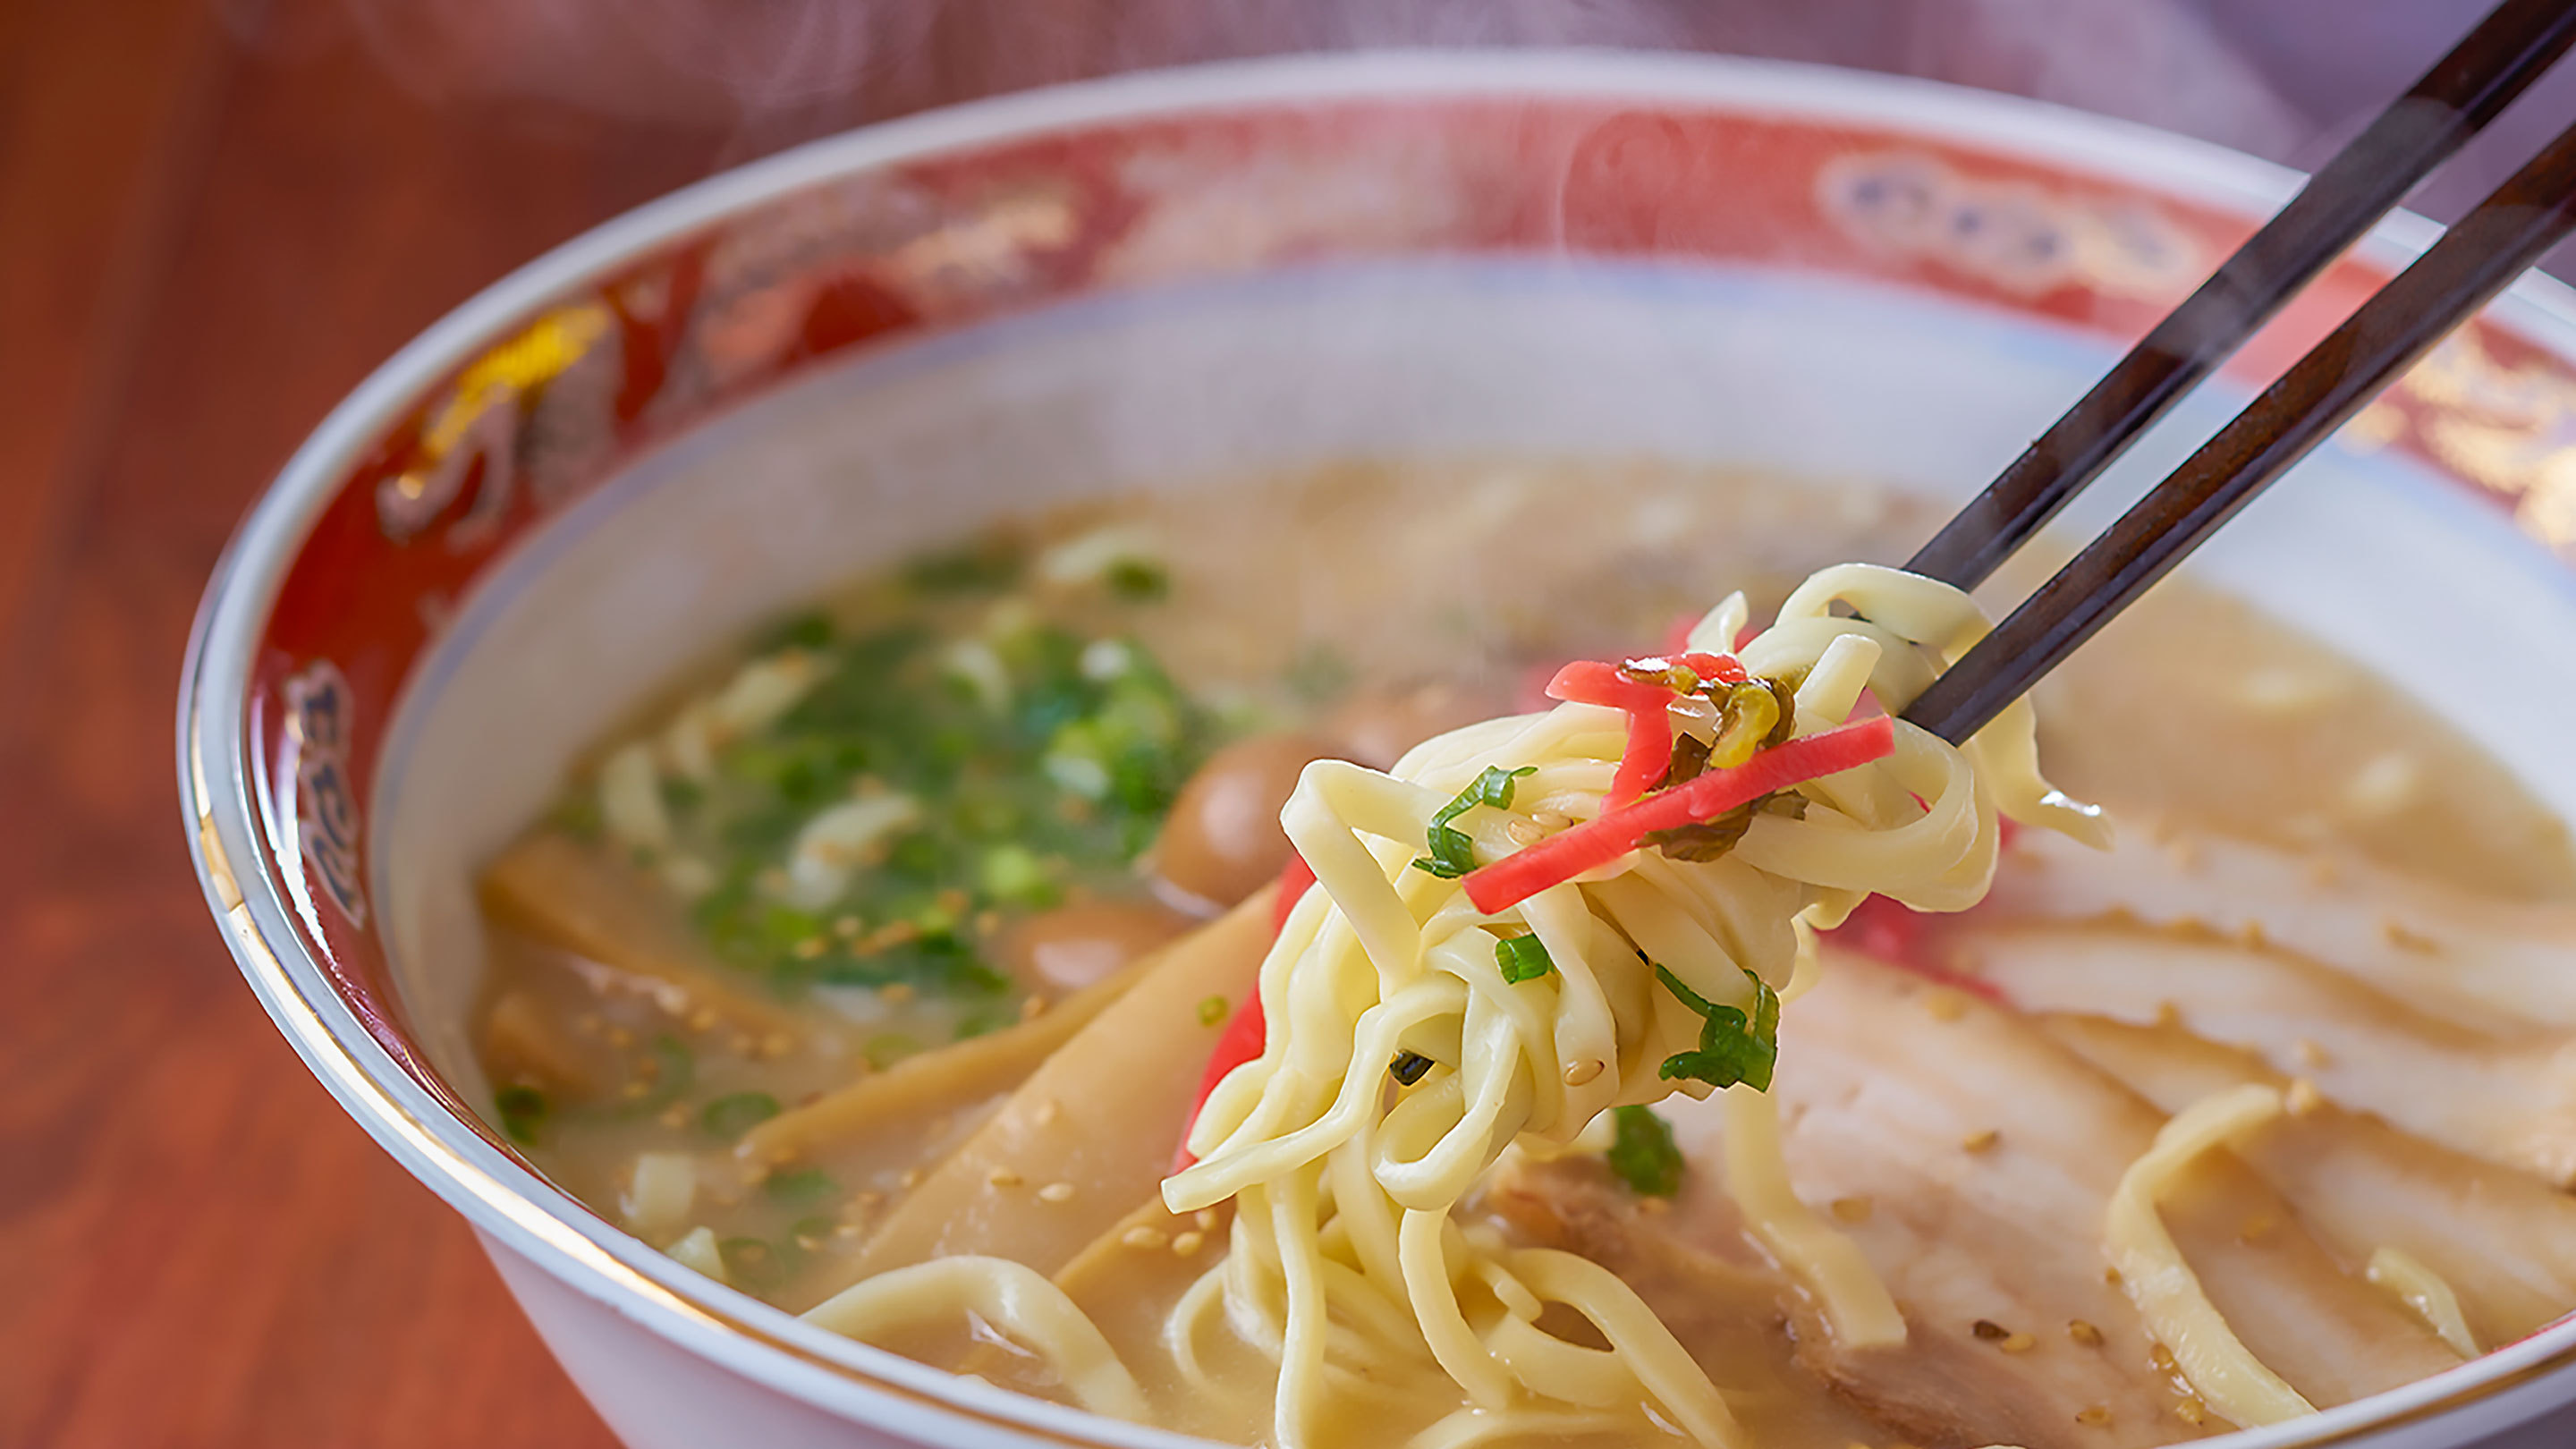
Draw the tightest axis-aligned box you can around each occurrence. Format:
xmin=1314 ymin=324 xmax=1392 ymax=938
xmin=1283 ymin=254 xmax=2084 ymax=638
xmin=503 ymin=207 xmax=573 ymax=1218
xmin=1988 ymin=827 xmax=2576 ymax=1037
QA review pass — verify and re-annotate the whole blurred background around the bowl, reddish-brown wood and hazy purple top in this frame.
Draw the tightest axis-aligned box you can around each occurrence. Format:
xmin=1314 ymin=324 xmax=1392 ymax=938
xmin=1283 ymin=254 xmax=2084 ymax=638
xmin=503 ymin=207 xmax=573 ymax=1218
xmin=0 ymin=0 xmax=2534 ymax=1449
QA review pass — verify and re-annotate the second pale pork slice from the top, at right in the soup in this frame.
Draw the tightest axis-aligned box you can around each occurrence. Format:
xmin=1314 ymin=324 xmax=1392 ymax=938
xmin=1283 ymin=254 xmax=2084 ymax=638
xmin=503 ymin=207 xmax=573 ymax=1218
xmin=1950 ymin=923 xmax=2576 ymax=1186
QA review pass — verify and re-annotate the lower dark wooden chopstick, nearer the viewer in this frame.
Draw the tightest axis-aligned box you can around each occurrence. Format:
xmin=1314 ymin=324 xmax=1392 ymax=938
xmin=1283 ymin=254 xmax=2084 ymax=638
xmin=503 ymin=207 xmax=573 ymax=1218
xmin=1906 ymin=114 xmax=2576 ymax=742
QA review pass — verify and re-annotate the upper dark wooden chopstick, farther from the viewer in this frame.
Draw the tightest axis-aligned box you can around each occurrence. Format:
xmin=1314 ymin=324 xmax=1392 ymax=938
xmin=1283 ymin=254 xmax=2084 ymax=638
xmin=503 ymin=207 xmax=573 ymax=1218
xmin=1906 ymin=0 xmax=2576 ymax=588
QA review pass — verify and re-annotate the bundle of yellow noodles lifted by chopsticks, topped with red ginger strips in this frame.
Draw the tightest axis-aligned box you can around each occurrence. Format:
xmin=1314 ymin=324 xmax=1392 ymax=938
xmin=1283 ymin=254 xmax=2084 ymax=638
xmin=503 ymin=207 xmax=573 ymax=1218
xmin=1165 ymin=564 xmax=2107 ymax=1449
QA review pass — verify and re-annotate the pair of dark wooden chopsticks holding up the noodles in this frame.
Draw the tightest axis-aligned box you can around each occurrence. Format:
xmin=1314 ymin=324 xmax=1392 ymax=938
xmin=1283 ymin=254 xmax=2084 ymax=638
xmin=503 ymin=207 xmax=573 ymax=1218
xmin=1903 ymin=0 xmax=2576 ymax=742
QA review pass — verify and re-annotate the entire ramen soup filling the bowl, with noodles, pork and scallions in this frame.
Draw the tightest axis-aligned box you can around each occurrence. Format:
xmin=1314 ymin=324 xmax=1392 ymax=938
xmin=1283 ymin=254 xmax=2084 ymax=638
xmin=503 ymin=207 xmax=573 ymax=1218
xmin=477 ymin=464 xmax=2576 ymax=1449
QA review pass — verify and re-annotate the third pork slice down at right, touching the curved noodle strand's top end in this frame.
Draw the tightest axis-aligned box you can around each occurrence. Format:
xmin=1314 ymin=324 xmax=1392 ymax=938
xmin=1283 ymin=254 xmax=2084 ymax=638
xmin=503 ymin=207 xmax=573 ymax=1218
xmin=2046 ymin=1016 xmax=2576 ymax=1349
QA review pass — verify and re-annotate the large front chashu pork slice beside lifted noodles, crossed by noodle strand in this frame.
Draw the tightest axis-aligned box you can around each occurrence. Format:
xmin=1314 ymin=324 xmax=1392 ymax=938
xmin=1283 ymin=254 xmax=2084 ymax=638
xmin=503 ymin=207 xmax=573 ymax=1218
xmin=1504 ymin=956 xmax=2458 ymax=1449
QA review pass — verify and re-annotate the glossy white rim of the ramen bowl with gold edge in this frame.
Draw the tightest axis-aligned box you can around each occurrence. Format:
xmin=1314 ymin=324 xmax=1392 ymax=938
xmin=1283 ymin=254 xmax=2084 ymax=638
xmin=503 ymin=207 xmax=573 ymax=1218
xmin=191 ymin=49 xmax=2576 ymax=1449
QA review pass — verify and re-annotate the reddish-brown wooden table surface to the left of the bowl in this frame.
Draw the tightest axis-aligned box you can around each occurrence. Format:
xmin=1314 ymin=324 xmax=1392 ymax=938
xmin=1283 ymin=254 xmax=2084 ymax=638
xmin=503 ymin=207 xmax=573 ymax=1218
xmin=0 ymin=0 xmax=2513 ymax=1449
